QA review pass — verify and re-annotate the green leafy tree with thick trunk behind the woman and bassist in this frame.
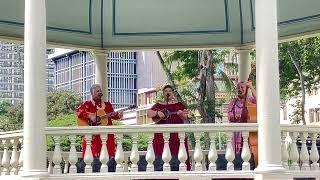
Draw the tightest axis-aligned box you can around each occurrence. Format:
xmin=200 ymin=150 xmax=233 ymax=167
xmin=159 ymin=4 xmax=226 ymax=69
xmin=157 ymin=50 xmax=234 ymax=123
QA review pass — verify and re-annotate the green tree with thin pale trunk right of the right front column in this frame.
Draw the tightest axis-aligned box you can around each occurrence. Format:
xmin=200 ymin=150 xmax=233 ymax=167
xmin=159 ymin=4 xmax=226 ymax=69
xmin=279 ymin=37 xmax=320 ymax=124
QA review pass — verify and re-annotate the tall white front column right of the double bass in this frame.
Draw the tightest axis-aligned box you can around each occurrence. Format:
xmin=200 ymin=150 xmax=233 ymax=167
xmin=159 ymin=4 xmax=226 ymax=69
xmin=255 ymin=0 xmax=284 ymax=176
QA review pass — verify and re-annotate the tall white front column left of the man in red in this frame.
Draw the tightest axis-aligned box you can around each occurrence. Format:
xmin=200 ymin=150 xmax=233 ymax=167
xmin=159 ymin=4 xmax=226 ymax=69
xmin=23 ymin=0 xmax=48 ymax=177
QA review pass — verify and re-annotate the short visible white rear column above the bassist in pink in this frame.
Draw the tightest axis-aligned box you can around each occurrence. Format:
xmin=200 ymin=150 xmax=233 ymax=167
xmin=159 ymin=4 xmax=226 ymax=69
xmin=238 ymin=49 xmax=251 ymax=82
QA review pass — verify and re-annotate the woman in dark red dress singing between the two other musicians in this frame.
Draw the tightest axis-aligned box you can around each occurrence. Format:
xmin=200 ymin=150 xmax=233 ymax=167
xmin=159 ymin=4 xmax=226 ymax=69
xmin=147 ymin=85 xmax=190 ymax=171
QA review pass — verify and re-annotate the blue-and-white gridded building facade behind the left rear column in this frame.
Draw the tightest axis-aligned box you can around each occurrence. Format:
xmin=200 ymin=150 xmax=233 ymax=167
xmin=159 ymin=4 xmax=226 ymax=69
xmin=52 ymin=51 xmax=137 ymax=108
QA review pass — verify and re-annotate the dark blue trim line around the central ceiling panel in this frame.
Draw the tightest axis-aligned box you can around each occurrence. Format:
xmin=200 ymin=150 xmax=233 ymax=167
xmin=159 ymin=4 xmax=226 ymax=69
xmin=112 ymin=0 xmax=230 ymax=36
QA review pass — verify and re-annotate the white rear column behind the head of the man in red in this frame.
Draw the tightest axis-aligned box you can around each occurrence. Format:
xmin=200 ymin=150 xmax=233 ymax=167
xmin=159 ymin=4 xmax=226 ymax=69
xmin=93 ymin=51 xmax=108 ymax=101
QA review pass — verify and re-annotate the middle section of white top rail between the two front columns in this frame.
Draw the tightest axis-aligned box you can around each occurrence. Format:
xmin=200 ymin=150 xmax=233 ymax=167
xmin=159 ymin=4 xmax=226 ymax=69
xmin=46 ymin=123 xmax=258 ymax=135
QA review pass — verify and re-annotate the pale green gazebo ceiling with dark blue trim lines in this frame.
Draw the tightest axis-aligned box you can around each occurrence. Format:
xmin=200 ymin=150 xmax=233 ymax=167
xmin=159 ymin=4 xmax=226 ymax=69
xmin=0 ymin=0 xmax=320 ymax=49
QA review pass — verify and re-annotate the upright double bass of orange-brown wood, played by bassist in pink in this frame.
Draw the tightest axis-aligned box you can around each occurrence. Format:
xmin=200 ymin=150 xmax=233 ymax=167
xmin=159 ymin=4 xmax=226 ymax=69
xmin=246 ymin=69 xmax=258 ymax=167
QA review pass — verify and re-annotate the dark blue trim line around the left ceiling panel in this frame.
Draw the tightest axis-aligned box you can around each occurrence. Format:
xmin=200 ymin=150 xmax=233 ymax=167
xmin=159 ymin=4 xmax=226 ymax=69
xmin=0 ymin=0 xmax=92 ymax=34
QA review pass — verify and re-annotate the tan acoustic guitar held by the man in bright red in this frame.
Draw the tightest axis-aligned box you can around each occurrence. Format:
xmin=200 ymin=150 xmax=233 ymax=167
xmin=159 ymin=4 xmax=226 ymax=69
xmin=77 ymin=105 xmax=136 ymax=126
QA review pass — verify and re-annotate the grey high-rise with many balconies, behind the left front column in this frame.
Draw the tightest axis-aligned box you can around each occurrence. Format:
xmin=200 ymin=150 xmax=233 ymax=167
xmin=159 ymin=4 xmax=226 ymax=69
xmin=0 ymin=42 xmax=54 ymax=104
